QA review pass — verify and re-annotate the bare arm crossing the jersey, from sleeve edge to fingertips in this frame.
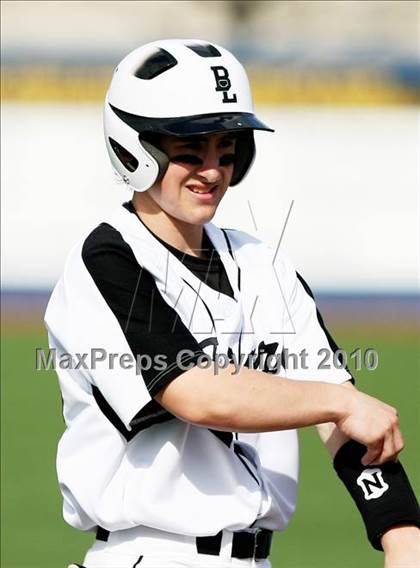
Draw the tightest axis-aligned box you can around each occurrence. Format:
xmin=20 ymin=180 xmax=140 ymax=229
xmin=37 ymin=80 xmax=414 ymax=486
xmin=156 ymin=366 xmax=403 ymax=465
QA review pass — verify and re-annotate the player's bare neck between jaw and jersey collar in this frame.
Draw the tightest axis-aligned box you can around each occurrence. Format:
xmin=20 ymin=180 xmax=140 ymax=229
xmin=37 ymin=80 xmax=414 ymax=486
xmin=132 ymin=193 xmax=203 ymax=257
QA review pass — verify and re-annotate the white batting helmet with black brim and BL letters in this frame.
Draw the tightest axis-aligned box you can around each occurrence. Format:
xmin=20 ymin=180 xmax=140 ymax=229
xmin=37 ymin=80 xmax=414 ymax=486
xmin=104 ymin=39 xmax=273 ymax=191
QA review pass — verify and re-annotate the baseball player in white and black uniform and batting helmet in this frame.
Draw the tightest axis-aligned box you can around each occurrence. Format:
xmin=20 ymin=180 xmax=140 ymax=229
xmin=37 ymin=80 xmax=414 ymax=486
xmin=46 ymin=40 xmax=419 ymax=568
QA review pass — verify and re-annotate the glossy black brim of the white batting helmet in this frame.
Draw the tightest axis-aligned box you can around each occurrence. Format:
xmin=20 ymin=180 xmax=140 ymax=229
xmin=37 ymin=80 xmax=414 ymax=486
xmin=109 ymin=104 xmax=274 ymax=136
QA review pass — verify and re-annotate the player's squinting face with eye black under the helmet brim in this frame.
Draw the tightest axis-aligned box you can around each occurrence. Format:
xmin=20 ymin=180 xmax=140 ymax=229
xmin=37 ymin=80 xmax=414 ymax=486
xmin=149 ymin=134 xmax=235 ymax=225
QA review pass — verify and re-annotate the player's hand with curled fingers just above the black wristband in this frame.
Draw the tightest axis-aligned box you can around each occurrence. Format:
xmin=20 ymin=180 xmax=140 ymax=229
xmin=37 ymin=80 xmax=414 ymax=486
xmin=336 ymin=389 xmax=404 ymax=466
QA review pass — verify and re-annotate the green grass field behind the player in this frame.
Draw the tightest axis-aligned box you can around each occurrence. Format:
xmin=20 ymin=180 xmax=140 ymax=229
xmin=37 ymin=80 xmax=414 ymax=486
xmin=1 ymin=329 xmax=420 ymax=568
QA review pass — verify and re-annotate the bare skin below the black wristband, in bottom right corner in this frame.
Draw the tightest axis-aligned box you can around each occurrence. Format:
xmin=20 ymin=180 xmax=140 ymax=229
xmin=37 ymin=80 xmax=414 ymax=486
xmin=381 ymin=525 xmax=420 ymax=568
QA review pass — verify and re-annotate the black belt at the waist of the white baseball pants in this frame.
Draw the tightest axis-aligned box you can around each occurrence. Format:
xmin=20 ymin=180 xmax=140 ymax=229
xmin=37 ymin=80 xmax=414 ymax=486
xmin=195 ymin=529 xmax=273 ymax=560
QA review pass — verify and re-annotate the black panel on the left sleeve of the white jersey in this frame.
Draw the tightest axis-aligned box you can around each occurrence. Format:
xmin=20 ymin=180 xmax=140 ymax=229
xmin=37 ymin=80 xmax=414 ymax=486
xmin=82 ymin=224 xmax=202 ymax=396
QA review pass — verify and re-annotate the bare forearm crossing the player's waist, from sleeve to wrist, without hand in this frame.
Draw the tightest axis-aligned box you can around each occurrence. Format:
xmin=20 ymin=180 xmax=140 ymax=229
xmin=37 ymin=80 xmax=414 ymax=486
xmin=157 ymin=367 xmax=347 ymax=432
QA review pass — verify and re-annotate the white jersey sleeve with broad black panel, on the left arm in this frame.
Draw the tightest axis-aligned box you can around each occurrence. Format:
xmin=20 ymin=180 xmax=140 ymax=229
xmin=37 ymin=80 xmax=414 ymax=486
xmin=46 ymin=223 xmax=202 ymax=430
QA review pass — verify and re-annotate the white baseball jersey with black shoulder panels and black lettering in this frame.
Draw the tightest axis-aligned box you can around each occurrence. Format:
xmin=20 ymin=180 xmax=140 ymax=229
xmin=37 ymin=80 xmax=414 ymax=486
xmin=46 ymin=203 xmax=351 ymax=536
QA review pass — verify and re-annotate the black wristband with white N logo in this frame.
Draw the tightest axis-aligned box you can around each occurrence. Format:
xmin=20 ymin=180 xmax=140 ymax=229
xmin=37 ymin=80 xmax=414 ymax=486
xmin=334 ymin=440 xmax=420 ymax=550
